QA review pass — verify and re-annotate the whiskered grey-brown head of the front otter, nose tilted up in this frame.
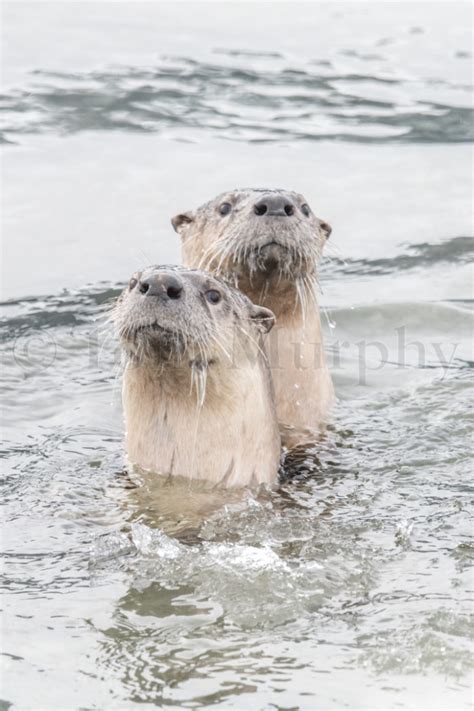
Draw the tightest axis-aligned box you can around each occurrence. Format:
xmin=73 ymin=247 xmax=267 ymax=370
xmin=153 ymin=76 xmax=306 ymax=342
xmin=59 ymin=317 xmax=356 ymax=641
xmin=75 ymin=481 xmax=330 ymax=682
xmin=113 ymin=266 xmax=275 ymax=398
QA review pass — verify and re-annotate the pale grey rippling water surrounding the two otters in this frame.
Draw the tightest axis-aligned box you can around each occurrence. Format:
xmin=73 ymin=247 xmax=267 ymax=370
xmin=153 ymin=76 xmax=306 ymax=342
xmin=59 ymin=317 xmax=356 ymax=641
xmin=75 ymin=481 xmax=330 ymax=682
xmin=0 ymin=3 xmax=473 ymax=710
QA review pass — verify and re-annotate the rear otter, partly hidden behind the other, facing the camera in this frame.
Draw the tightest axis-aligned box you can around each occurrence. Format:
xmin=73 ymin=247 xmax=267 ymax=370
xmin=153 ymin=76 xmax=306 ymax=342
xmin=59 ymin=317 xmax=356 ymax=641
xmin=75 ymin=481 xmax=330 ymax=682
xmin=171 ymin=188 xmax=334 ymax=446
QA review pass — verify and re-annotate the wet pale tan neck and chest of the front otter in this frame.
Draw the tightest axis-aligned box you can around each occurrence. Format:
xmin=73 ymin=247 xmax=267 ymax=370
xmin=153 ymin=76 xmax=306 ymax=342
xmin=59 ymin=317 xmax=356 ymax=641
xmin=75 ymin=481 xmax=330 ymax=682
xmin=123 ymin=359 xmax=280 ymax=486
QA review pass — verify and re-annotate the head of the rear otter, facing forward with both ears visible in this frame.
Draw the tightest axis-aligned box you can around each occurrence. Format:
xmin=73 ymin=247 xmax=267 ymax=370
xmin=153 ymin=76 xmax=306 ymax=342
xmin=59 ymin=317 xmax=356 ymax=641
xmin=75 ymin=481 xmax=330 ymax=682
xmin=172 ymin=189 xmax=331 ymax=288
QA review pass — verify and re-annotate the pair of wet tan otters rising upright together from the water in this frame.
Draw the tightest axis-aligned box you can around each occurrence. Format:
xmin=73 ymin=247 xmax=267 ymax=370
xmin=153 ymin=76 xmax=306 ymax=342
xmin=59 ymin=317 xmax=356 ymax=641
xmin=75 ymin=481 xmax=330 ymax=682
xmin=115 ymin=190 xmax=333 ymax=486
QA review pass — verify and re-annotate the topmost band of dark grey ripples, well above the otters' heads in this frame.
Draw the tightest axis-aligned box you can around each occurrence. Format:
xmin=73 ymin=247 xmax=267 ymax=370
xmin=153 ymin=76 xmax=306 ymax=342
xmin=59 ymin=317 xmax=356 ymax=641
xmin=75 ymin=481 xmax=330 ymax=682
xmin=0 ymin=50 xmax=474 ymax=143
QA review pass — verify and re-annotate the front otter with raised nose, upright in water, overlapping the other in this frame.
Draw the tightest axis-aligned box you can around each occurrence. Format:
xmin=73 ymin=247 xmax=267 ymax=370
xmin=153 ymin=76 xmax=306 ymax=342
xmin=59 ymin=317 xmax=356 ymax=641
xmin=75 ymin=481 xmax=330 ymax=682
xmin=112 ymin=266 xmax=281 ymax=487
